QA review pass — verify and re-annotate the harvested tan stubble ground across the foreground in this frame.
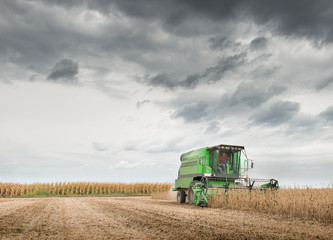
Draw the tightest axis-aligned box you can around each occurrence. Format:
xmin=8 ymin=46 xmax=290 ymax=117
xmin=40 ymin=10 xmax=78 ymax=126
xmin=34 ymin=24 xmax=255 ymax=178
xmin=0 ymin=197 xmax=333 ymax=239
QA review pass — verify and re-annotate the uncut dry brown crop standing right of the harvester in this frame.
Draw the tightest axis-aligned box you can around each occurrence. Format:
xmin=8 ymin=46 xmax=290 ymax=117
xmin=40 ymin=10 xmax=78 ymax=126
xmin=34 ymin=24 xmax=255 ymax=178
xmin=209 ymin=186 xmax=333 ymax=224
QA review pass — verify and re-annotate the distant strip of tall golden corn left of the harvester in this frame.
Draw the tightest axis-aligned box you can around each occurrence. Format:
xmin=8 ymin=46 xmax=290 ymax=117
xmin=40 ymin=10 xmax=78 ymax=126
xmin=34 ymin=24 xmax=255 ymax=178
xmin=0 ymin=182 xmax=171 ymax=197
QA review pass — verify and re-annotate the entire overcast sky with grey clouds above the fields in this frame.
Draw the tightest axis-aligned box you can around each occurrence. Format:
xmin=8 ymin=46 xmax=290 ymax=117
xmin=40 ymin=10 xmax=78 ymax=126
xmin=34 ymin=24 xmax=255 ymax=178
xmin=0 ymin=0 xmax=333 ymax=186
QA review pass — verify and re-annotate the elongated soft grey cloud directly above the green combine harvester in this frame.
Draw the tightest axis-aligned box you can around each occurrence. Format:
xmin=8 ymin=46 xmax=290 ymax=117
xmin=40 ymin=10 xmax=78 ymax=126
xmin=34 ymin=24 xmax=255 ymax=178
xmin=169 ymin=82 xmax=287 ymax=124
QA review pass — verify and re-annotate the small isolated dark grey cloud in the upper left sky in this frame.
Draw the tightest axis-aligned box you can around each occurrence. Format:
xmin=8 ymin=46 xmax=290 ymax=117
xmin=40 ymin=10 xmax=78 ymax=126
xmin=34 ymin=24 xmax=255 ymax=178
xmin=47 ymin=58 xmax=79 ymax=82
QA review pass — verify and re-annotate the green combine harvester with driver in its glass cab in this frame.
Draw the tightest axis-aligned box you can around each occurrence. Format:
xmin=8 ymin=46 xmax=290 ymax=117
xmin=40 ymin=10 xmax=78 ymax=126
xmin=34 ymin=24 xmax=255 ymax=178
xmin=173 ymin=144 xmax=279 ymax=207
